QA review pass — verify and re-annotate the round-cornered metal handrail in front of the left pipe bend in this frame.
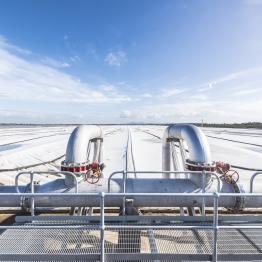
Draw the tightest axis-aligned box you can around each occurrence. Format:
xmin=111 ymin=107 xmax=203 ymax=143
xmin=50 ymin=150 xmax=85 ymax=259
xmin=15 ymin=171 xmax=78 ymax=193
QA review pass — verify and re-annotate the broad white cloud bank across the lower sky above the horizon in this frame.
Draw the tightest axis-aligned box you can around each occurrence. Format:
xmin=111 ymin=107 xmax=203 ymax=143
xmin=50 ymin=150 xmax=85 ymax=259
xmin=0 ymin=37 xmax=262 ymax=123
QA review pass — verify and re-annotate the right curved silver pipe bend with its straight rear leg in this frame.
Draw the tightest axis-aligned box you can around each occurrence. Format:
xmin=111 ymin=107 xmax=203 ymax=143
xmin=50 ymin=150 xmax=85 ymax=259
xmin=162 ymin=124 xmax=212 ymax=171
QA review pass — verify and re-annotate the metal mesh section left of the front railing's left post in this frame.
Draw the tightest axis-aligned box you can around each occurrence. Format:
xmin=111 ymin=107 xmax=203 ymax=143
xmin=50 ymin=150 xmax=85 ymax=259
xmin=0 ymin=229 xmax=100 ymax=254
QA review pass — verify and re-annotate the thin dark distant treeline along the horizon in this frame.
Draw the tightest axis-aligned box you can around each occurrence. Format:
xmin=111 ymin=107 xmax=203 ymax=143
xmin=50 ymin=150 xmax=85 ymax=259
xmin=0 ymin=122 xmax=262 ymax=129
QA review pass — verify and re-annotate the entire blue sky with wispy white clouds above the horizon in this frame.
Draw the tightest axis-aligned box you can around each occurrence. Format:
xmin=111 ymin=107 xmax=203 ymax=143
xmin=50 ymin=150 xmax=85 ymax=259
xmin=0 ymin=0 xmax=262 ymax=123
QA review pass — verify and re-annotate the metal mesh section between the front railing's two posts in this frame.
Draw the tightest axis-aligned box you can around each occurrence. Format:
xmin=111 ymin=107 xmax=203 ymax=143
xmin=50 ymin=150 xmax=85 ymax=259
xmin=106 ymin=226 xmax=213 ymax=254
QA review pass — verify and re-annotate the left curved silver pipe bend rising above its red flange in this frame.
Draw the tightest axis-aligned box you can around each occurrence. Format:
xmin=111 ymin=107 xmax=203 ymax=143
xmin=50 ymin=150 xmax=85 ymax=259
xmin=65 ymin=125 xmax=103 ymax=164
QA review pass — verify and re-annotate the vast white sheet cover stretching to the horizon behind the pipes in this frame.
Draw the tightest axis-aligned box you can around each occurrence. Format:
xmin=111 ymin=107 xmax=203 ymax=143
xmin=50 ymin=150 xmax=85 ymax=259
xmin=0 ymin=125 xmax=262 ymax=189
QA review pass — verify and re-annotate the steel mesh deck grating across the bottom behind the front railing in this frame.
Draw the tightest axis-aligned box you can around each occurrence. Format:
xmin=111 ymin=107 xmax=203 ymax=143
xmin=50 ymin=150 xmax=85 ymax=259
xmin=0 ymin=220 xmax=262 ymax=262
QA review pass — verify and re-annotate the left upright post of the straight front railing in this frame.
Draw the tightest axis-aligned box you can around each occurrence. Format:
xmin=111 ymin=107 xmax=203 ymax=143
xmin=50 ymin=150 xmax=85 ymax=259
xmin=100 ymin=192 xmax=105 ymax=262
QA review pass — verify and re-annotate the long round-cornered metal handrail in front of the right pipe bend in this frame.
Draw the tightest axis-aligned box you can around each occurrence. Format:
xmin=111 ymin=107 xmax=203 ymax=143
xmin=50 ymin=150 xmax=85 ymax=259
xmin=107 ymin=170 xmax=221 ymax=193
